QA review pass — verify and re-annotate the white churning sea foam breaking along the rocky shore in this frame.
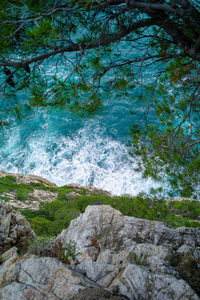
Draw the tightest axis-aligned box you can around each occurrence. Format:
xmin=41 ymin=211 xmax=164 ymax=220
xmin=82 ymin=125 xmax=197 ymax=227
xmin=0 ymin=121 xmax=157 ymax=195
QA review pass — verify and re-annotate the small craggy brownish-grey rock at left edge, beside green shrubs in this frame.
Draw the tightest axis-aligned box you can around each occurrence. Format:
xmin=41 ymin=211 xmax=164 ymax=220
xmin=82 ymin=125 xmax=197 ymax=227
xmin=0 ymin=200 xmax=35 ymax=254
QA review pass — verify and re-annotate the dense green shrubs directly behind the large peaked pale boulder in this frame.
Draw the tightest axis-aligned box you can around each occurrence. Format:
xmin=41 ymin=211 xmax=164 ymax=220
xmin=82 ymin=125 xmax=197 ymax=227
xmin=21 ymin=192 xmax=200 ymax=236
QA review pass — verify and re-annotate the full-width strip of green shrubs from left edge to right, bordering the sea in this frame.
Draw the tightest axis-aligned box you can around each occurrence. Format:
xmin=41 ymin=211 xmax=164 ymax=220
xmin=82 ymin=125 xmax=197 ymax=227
xmin=0 ymin=176 xmax=200 ymax=236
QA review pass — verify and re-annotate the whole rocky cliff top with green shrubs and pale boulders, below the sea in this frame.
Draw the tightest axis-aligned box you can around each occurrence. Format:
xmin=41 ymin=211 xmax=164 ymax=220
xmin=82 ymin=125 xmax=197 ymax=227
xmin=0 ymin=173 xmax=200 ymax=300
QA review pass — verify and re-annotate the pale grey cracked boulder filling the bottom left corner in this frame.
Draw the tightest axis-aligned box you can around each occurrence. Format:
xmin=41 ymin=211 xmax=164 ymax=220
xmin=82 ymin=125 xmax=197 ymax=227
xmin=0 ymin=255 xmax=98 ymax=300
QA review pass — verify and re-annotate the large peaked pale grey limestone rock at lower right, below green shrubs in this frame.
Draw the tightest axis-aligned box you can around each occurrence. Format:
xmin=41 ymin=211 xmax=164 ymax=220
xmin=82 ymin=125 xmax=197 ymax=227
xmin=56 ymin=205 xmax=200 ymax=300
